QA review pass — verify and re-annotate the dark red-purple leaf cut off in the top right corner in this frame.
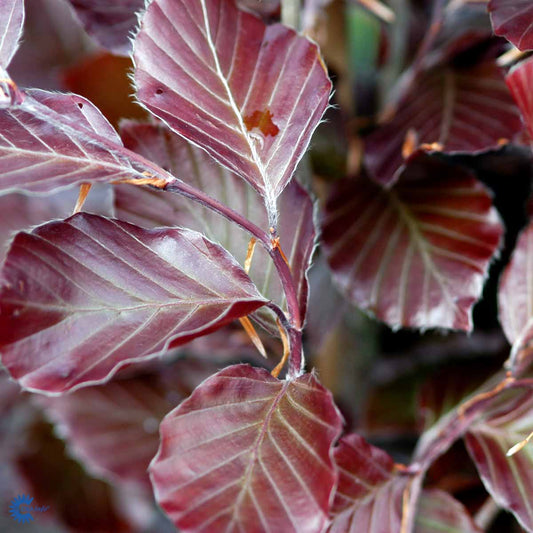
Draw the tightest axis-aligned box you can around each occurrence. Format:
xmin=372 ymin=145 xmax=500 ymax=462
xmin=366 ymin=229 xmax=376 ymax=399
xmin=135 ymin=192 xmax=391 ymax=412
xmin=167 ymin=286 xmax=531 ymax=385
xmin=488 ymin=0 xmax=533 ymax=50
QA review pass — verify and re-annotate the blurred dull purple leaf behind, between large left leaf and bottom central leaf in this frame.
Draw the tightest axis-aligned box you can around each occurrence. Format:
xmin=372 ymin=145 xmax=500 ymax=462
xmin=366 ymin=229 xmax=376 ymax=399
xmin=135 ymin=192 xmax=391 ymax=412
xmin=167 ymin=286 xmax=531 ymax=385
xmin=37 ymin=359 xmax=218 ymax=491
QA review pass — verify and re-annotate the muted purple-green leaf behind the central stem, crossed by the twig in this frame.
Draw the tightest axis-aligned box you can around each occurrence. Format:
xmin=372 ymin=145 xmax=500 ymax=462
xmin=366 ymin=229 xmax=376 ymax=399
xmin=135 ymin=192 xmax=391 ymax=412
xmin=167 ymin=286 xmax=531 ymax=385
xmin=115 ymin=121 xmax=315 ymax=334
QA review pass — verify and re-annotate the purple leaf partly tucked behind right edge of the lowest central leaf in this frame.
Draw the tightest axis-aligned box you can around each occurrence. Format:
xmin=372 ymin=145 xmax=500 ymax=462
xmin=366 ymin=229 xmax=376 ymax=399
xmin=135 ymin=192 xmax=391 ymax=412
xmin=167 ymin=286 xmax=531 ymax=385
xmin=328 ymin=433 xmax=422 ymax=533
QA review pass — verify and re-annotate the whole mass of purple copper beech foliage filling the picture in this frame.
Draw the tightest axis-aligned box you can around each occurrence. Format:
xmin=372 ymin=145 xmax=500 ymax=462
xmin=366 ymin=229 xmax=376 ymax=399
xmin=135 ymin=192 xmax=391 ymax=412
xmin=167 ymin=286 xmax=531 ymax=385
xmin=0 ymin=0 xmax=533 ymax=533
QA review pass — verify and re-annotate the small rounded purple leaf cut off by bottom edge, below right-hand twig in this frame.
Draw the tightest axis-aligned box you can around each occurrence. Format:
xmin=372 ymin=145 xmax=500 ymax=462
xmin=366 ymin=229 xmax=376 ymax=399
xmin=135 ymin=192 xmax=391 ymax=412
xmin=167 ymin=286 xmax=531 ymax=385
xmin=414 ymin=489 xmax=482 ymax=533
